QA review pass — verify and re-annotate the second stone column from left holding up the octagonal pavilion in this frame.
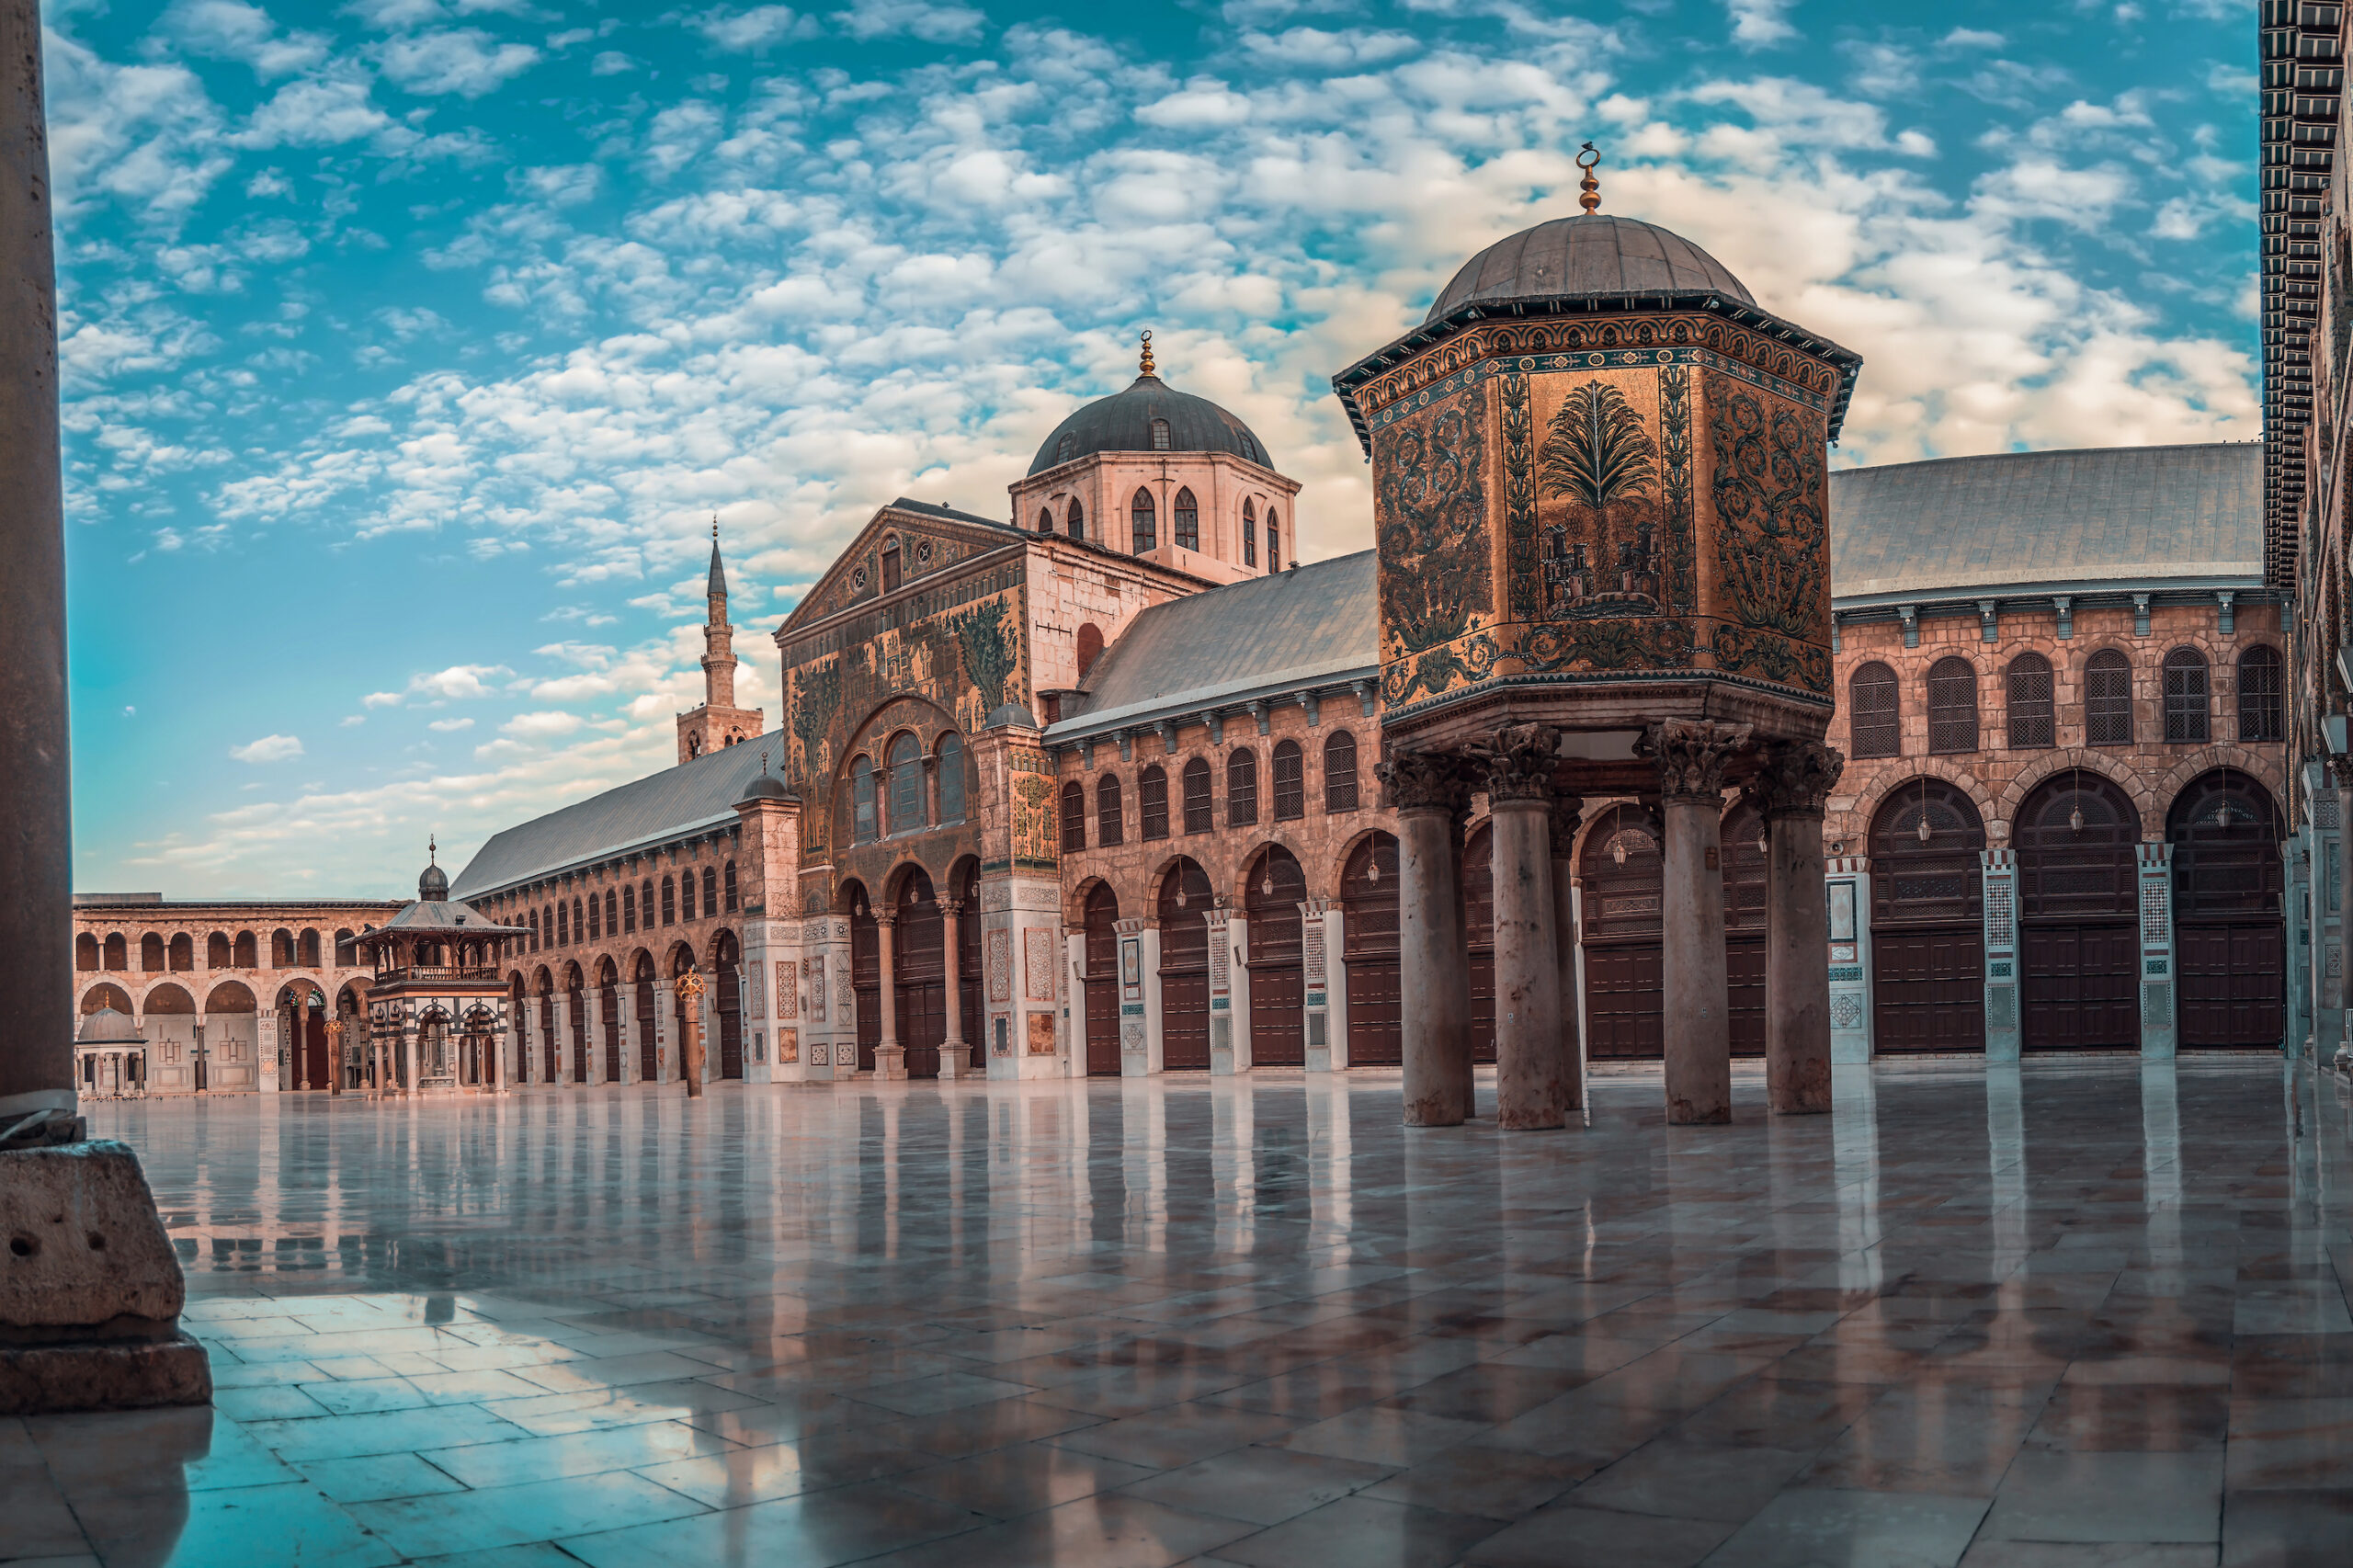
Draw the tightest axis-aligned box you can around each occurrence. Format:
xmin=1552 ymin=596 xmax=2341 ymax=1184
xmin=1480 ymin=725 xmax=1567 ymax=1131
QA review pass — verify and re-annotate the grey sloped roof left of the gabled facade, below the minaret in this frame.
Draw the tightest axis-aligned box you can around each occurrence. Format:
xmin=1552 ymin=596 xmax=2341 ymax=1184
xmin=449 ymin=728 xmax=783 ymax=900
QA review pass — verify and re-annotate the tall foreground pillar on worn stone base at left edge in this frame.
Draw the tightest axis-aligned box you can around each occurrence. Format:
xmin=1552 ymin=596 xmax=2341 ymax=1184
xmin=0 ymin=0 xmax=211 ymax=1412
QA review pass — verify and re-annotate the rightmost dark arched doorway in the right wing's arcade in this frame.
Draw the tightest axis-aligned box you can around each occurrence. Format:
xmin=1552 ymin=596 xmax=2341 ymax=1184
xmin=2165 ymin=767 xmax=2287 ymax=1050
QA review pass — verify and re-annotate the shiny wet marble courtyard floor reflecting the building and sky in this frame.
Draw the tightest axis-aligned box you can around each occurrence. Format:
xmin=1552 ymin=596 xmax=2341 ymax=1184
xmin=0 ymin=1057 xmax=2353 ymax=1568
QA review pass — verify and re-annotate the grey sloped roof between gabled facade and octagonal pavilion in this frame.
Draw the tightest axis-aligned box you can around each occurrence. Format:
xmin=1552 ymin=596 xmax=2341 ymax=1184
xmin=1047 ymin=551 xmax=1381 ymax=737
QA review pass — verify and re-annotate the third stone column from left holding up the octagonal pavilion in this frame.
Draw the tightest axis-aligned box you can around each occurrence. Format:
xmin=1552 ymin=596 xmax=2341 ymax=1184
xmin=1638 ymin=718 xmax=1748 ymax=1125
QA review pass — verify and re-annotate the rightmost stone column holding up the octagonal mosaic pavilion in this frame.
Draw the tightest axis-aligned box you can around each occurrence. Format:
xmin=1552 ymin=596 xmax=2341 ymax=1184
xmin=1751 ymin=742 xmax=1847 ymax=1116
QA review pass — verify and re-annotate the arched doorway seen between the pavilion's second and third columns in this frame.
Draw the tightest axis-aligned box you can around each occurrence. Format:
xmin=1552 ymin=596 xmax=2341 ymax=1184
xmin=1572 ymin=805 xmax=1665 ymax=1062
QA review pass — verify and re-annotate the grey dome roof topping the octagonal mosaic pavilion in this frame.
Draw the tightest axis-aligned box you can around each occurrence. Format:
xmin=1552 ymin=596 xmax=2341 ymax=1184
xmin=1424 ymin=212 xmax=1756 ymax=323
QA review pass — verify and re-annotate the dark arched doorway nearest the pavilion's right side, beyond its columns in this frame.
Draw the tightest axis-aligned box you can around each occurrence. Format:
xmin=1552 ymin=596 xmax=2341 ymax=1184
xmin=1870 ymin=779 xmax=1986 ymax=1052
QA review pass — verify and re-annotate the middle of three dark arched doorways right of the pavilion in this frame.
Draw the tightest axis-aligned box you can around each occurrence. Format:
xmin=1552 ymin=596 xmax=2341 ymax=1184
xmin=2017 ymin=767 xmax=2142 ymax=1050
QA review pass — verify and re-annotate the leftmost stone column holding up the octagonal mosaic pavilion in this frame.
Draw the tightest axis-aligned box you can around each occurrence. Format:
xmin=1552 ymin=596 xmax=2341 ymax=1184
xmin=1377 ymin=751 xmax=1471 ymax=1128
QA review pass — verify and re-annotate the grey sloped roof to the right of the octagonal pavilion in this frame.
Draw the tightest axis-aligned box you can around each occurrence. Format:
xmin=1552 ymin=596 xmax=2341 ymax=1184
xmin=1831 ymin=440 xmax=2264 ymax=600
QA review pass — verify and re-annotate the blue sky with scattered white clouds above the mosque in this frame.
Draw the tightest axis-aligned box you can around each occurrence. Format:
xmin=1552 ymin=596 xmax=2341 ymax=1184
xmin=47 ymin=0 xmax=2259 ymax=897
